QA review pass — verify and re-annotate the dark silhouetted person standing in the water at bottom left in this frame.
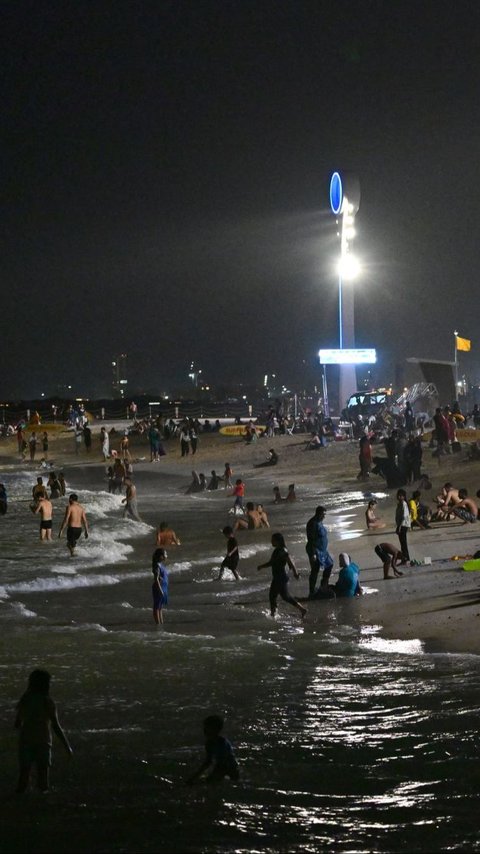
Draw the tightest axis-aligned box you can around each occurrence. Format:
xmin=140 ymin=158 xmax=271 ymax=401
xmin=15 ymin=670 xmax=73 ymax=793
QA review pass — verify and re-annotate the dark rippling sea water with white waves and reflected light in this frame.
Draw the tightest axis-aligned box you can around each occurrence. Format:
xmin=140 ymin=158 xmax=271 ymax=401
xmin=0 ymin=469 xmax=480 ymax=852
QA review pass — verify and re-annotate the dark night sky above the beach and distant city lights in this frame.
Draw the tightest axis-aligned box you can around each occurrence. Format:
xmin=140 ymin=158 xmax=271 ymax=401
xmin=0 ymin=0 xmax=480 ymax=396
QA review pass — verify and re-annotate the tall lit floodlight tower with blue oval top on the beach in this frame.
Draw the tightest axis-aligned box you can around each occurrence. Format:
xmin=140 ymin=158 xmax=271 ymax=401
xmin=330 ymin=172 xmax=360 ymax=410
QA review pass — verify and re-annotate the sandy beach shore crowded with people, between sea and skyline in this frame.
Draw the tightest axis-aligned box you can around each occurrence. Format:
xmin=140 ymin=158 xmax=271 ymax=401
xmin=0 ymin=427 xmax=480 ymax=654
